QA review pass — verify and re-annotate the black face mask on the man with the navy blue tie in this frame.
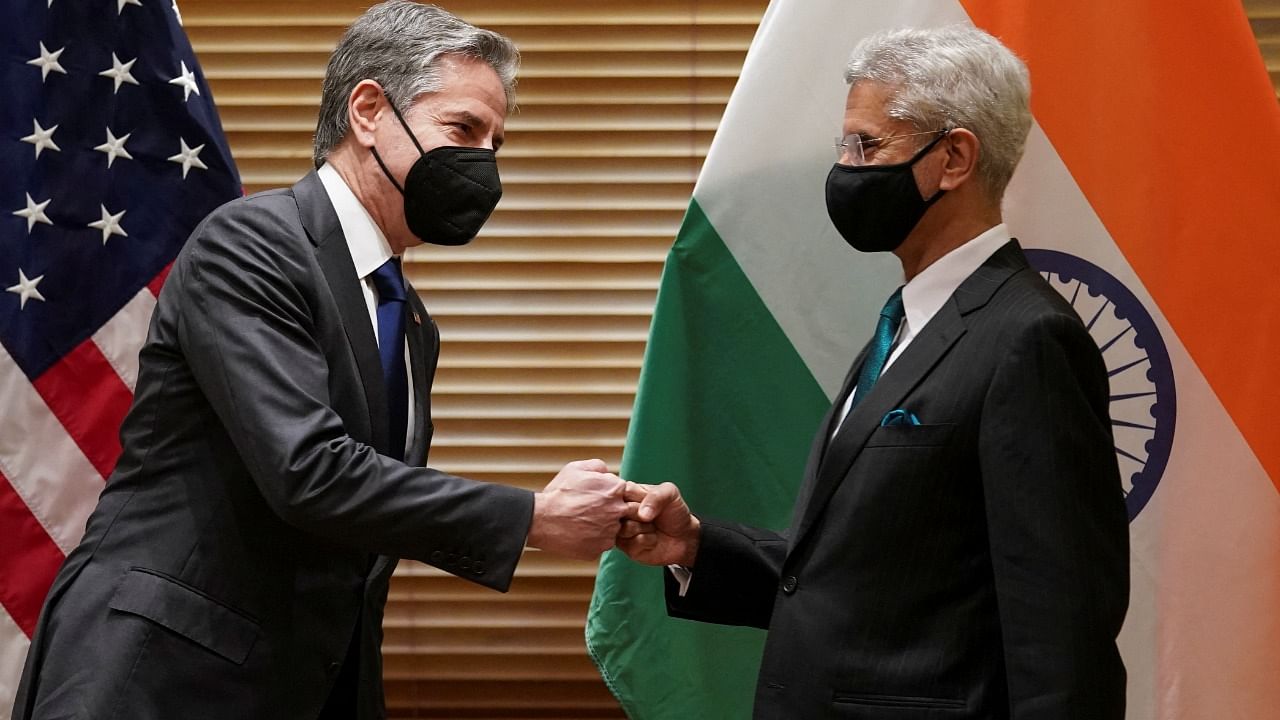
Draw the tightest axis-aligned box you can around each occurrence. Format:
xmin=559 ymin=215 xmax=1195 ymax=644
xmin=372 ymin=99 xmax=502 ymax=245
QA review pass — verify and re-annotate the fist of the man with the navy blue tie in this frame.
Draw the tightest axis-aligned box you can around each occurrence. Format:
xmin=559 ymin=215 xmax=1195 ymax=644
xmin=529 ymin=460 xmax=627 ymax=560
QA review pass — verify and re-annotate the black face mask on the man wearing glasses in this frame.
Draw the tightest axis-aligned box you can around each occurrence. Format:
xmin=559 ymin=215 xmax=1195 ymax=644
xmin=827 ymin=132 xmax=946 ymax=252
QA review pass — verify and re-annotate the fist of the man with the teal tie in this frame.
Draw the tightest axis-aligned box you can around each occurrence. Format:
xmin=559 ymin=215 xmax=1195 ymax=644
xmin=618 ymin=482 xmax=701 ymax=569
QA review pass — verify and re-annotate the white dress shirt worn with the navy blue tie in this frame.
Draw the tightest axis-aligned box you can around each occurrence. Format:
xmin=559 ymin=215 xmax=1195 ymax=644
xmin=316 ymin=163 xmax=415 ymax=456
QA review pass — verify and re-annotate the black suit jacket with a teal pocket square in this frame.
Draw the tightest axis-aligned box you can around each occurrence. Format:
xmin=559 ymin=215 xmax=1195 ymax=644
xmin=667 ymin=242 xmax=1129 ymax=720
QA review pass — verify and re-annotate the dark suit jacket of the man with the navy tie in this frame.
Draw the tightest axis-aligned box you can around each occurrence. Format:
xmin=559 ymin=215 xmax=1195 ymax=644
xmin=14 ymin=173 xmax=532 ymax=720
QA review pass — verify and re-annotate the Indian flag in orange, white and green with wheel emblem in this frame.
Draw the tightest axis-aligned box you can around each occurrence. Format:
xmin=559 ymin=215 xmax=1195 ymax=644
xmin=588 ymin=0 xmax=1280 ymax=720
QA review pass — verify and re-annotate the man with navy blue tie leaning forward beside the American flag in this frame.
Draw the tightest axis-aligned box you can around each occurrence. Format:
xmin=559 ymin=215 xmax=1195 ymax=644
xmin=14 ymin=1 xmax=626 ymax=720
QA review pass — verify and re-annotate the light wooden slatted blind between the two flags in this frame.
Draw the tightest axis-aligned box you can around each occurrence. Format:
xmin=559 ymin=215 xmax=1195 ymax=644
xmin=179 ymin=0 xmax=767 ymax=719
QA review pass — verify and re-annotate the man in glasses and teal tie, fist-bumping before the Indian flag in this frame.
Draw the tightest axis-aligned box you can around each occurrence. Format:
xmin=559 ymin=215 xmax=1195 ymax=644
xmin=618 ymin=26 xmax=1129 ymax=720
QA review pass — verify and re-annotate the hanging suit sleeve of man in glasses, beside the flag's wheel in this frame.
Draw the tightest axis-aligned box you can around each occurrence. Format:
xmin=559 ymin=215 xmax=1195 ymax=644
xmin=979 ymin=310 xmax=1129 ymax=720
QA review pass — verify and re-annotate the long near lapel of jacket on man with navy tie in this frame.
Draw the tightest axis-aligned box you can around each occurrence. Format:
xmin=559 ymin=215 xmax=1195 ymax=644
xmin=293 ymin=172 xmax=389 ymax=452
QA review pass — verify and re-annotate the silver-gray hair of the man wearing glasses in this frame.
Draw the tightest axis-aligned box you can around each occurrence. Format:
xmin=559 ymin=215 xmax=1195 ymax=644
xmin=845 ymin=24 xmax=1032 ymax=201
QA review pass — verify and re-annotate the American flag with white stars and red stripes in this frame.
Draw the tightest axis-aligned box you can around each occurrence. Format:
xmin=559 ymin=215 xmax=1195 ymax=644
xmin=0 ymin=0 xmax=241 ymax=717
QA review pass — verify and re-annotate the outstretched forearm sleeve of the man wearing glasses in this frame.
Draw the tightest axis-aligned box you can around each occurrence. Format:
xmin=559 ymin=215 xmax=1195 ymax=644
xmin=664 ymin=520 xmax=787 ymax=629
